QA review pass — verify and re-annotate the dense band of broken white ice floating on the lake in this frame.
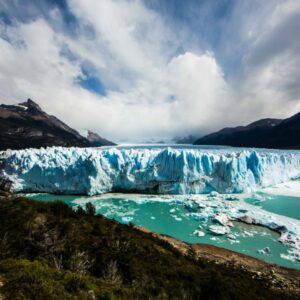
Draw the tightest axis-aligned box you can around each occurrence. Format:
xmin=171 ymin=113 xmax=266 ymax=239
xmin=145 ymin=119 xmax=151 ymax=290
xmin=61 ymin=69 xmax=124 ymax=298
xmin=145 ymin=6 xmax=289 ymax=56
xmin=182 ymin=195 xmax=300 ymax=261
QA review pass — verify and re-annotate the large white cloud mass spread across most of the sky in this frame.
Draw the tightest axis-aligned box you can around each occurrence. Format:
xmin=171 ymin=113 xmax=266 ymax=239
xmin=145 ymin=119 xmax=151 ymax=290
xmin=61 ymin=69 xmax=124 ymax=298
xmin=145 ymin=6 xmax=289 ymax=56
xmin=0 ymin=0 xmax=300 ymax=141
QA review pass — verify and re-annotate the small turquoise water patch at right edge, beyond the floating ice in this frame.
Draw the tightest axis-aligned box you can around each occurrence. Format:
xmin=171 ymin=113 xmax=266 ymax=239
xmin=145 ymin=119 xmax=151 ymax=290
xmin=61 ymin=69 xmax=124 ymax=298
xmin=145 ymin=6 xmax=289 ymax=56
xmin=245 ymin=193 xmax=300 ymax=220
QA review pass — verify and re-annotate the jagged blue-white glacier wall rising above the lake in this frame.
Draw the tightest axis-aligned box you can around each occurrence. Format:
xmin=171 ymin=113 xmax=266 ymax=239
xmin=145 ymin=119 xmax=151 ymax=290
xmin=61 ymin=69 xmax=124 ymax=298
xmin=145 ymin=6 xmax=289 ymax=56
xmin=0 ymin=147 xmax=300 ymax=195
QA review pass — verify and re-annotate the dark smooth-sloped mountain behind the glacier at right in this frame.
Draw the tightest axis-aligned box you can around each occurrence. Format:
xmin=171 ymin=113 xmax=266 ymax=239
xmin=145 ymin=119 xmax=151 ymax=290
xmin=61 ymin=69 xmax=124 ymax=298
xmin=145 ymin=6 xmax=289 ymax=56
xmin=194 ymin=113 xmax=300 ymax=149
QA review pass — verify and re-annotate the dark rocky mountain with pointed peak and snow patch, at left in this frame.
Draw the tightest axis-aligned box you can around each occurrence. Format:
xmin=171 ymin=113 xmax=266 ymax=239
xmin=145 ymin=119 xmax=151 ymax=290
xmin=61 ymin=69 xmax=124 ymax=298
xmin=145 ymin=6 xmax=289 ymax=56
xmin=0 ymin=99 xmax=112 ymax=150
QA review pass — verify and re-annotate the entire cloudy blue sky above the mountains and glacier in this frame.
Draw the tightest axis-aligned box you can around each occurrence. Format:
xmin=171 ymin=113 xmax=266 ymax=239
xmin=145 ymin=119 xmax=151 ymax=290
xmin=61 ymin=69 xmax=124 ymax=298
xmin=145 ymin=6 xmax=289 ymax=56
xmin=0 ymin=0 xmax=300 ymax=142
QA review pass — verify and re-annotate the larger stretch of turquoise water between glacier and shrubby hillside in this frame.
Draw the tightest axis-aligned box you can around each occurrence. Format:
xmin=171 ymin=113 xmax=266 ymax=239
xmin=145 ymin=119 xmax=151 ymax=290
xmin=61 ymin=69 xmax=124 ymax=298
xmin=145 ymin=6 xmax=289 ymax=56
xmin=28 ymin=194 xmax=300 ymax=269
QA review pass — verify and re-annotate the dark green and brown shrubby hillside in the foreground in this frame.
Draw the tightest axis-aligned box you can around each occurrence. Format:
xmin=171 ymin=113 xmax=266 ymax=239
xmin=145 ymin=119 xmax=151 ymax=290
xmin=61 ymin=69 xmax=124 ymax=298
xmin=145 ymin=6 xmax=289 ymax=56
xmin=0 ymin=198 xmax=293 ymax=300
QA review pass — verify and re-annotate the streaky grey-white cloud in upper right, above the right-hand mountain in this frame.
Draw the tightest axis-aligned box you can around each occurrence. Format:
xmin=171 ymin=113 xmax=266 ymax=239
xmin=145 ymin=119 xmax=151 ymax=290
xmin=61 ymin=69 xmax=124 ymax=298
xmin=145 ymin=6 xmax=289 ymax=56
xmin=234 ymin=1 xmax=300 ymax=117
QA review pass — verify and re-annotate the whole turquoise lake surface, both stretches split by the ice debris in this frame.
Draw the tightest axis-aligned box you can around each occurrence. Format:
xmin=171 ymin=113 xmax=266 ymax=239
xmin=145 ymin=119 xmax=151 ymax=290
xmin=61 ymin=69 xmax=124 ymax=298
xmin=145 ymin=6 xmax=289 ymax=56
xmin=28 ymin=194 xmax=300 ymax=269
